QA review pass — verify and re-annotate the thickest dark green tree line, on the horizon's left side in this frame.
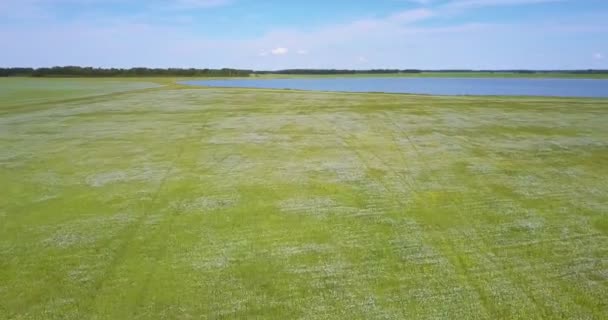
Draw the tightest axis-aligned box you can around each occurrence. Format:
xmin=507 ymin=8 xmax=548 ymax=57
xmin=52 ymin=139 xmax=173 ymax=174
xmin=0 ymin=66 xmax=253 ymax=77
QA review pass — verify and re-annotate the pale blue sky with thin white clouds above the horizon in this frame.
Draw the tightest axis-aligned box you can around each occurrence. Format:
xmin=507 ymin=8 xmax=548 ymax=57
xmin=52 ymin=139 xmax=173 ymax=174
xmin=0 ymin=0 xmax=608 ymax=70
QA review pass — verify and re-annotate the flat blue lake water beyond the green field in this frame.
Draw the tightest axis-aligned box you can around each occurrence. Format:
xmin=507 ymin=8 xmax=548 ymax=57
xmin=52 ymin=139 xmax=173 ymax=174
xmin=182 ymin=78 xmax=608 ymax=97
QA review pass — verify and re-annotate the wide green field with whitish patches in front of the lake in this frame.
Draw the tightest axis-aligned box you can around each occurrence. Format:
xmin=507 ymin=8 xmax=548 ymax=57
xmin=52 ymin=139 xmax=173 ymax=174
xmin=0 ymin=79 xmax=608 ymax=319
